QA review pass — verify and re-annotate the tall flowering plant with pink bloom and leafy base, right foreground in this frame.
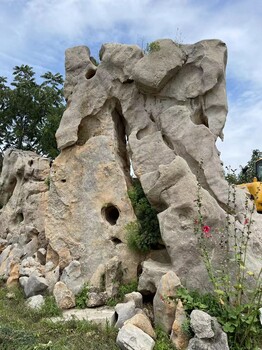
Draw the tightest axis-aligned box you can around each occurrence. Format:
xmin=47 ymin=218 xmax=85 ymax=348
xmin=192 ymin=179 xmax=262 ymax=350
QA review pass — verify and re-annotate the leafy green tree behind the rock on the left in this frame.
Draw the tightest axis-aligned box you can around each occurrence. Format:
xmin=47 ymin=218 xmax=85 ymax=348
xmin=0 ymin=65 xmax=65 ymax=158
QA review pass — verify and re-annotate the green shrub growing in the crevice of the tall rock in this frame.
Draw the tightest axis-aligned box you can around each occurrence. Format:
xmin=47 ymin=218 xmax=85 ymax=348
xmin=126 ymin=179 xmax=161 ymax=252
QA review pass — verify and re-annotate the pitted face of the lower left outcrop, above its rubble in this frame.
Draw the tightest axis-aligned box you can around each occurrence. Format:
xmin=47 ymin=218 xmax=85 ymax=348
xmin=0 ymin=149 xmax=50 ymax=245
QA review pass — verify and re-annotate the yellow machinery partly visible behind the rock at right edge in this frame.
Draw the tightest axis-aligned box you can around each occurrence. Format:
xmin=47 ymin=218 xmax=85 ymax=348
xmin=239 ymin=158 xmax=262 ymax=213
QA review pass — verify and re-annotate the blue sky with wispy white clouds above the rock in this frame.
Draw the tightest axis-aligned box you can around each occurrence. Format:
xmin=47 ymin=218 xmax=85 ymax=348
xmin=0 ymin=0 xmax=262 ymax=168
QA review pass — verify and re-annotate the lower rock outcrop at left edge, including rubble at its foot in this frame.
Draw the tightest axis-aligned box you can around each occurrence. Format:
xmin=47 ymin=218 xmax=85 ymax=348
xmin=0 ymin=149 xmax=50 ymax=296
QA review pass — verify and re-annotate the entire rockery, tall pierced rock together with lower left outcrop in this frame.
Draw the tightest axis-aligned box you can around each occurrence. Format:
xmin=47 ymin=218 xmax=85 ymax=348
xmin=0 ymin=39 xmax=262 ymax=300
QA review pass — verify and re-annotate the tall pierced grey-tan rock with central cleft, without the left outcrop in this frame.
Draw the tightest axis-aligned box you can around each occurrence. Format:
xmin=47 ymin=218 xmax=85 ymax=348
xmin=46 ymin=39 xmax=261 ymax=292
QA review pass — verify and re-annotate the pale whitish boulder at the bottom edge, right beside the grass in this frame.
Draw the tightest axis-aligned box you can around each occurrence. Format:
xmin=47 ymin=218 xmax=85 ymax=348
xmin=116 ymin=324 xmax=155 ymax=350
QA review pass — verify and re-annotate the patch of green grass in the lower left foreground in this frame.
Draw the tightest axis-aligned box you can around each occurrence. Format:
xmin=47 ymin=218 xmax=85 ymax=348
xmin=0 ymin=287 xmax=118 ymax=350
